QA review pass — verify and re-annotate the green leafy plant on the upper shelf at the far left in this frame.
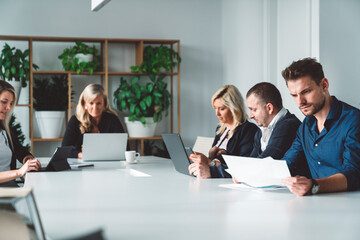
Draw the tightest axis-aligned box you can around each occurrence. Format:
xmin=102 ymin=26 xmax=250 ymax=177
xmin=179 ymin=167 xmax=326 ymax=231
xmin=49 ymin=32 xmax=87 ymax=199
xmin=0 ymin=43 xmax=39 ymax=87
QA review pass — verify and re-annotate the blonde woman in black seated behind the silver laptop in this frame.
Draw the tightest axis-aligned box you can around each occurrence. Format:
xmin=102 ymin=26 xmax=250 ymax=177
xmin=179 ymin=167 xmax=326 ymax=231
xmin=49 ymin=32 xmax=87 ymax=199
xmin=61 ymin=84 xmax=124 ymax=158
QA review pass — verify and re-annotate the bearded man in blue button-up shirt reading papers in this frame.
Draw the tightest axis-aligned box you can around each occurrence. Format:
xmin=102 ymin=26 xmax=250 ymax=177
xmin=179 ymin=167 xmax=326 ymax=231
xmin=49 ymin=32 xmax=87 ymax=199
xmin=282 ymin=58 xmax=360 ymax=196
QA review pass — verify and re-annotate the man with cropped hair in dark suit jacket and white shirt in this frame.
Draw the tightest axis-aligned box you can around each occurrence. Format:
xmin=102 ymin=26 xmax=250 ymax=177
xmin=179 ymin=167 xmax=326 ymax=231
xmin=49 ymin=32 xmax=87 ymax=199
xmin=246 ymin=82 xmax=301 ymax=159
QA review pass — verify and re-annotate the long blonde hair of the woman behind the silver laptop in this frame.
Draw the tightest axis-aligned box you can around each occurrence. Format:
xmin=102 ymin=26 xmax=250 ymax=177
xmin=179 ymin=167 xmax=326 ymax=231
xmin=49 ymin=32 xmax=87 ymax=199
xmin=75 ymin=84 xmax=117 ymax=133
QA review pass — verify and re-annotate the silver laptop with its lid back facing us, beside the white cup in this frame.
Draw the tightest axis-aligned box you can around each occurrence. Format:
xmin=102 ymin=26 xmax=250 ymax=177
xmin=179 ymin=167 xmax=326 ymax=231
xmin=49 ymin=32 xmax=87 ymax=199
xmin=82 ymin=133 xmax=128 ymax=161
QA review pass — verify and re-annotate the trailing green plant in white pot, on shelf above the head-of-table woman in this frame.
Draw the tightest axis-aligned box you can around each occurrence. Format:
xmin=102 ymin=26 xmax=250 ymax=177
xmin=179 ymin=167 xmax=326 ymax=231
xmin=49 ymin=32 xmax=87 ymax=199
xmin=58 ymin=41 xmax=101 ymax=74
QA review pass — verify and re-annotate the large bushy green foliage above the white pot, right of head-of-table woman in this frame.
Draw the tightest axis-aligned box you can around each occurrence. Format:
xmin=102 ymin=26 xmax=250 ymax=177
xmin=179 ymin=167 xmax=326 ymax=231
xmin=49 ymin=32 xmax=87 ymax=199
xmin=114 ymin=74 xmax=171 ymax=124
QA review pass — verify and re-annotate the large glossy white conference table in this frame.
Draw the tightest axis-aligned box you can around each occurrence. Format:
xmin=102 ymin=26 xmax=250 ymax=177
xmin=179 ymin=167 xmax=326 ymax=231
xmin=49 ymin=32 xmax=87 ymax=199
xmin=25 ymin=157 xmax=360 ymax=240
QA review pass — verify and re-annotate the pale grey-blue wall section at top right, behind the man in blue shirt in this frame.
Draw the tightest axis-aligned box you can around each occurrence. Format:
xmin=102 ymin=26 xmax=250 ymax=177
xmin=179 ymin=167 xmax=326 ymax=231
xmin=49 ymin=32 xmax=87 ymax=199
xmin=320 ymin=0 xmax=360 ymax=108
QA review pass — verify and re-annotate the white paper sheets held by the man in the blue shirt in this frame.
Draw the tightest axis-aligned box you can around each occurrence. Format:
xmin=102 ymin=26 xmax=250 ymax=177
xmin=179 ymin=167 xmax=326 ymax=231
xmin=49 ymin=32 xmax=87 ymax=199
xmin=223 ymin=155 xmax=290 ymax=188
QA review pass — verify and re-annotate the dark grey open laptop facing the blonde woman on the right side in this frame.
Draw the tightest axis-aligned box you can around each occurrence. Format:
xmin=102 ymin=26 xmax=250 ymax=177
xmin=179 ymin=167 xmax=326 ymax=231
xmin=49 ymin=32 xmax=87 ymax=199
xmin=161 ymin=133 xmax=192 ymax=175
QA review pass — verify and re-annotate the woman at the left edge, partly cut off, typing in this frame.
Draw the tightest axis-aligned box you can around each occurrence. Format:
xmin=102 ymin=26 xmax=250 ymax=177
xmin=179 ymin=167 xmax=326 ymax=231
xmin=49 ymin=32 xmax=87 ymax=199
xmin=0 ymin=80 xmax=41 ymax=187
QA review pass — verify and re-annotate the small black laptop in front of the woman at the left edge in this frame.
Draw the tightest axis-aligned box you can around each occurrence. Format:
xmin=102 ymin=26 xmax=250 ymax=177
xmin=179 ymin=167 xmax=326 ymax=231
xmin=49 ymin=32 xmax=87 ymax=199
xmin=39 ymin=146 xmax=72 ymax=172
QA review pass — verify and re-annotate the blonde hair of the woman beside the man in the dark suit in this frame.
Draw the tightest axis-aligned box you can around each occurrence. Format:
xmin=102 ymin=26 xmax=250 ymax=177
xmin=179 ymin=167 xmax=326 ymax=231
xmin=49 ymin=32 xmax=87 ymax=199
xmin=211 ymin=85 xmax=247 ymax=139
